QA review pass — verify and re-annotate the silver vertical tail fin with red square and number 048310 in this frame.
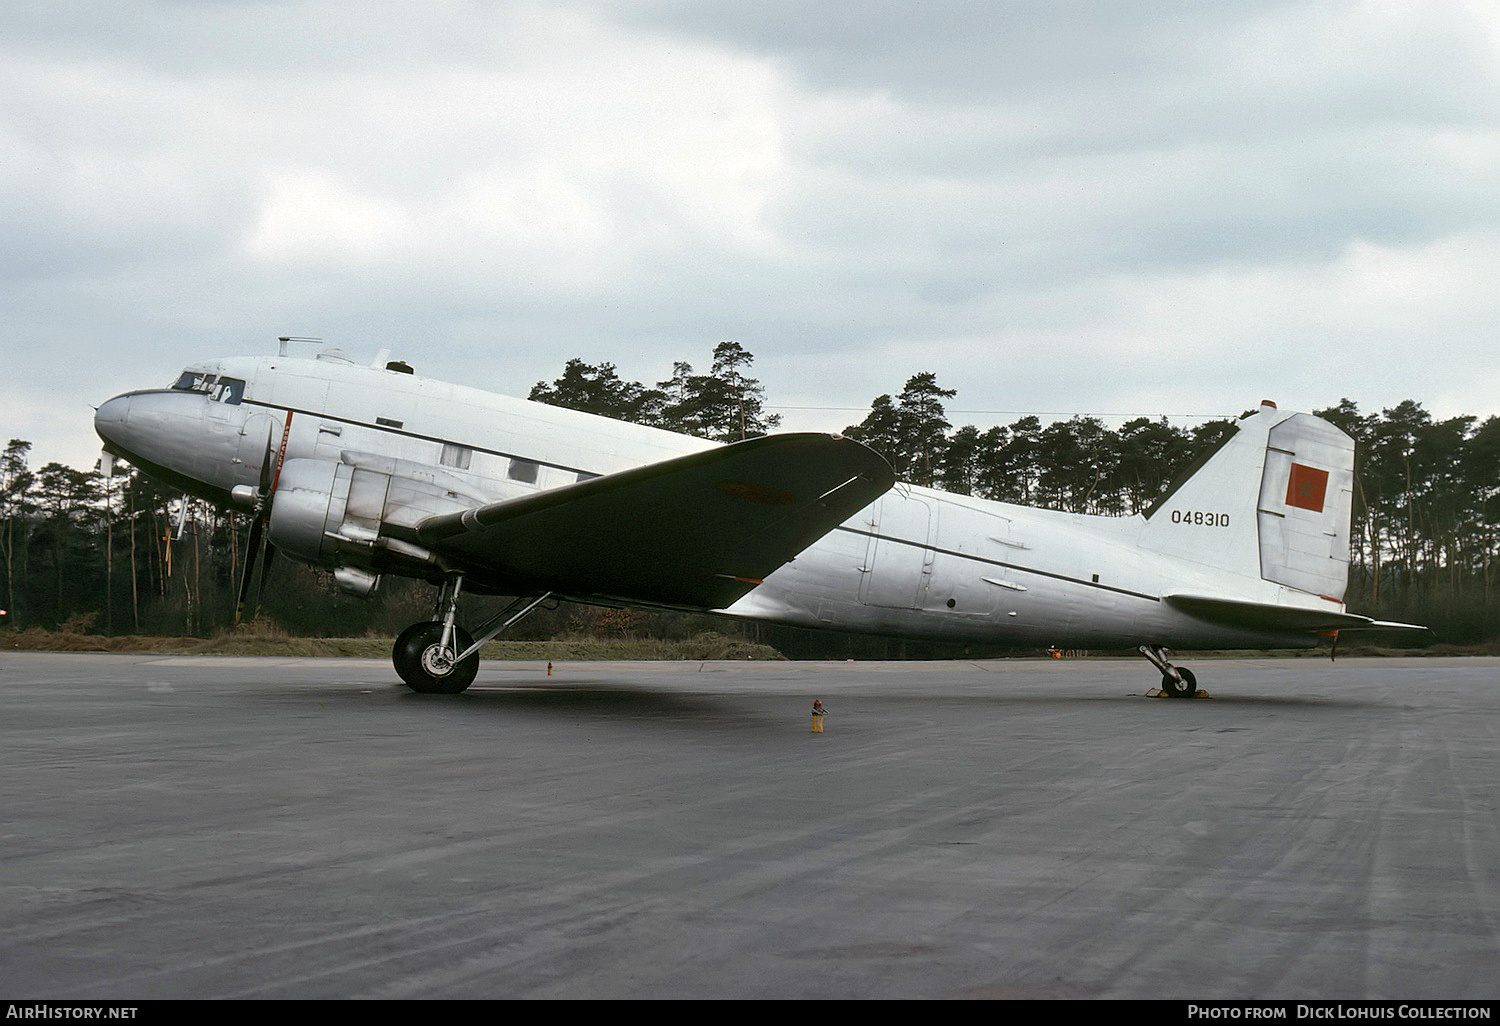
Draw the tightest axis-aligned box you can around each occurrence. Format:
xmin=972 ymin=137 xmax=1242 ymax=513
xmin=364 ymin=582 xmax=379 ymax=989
xmin=1142 ymin=402 xmax=1355 ymax=602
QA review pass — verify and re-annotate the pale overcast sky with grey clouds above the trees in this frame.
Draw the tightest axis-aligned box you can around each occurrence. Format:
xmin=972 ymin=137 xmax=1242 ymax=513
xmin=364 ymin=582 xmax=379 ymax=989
xmin=0 ymin=0 xmax=1500 ymax=468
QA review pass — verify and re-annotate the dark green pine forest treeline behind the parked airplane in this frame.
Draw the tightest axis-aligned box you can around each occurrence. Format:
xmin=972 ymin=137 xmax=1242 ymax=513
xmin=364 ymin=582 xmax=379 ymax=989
xmin=0 ymin=342 xmax=1500 ymax=648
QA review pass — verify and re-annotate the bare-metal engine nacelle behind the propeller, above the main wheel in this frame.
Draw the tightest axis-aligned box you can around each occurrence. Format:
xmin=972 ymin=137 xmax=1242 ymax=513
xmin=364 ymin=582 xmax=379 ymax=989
xmin=269 ymin=453 xmax=485 ymax=596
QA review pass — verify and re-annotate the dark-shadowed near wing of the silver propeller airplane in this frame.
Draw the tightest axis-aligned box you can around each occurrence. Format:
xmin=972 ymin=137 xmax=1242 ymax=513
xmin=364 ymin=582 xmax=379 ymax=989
xmin=416 ymin=434 xmax=896 ymax=609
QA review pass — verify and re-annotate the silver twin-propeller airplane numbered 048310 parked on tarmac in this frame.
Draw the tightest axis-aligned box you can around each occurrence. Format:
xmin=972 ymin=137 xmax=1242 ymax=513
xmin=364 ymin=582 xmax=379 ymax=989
xmin=95 ymin=339 xmax=1407 ymax=698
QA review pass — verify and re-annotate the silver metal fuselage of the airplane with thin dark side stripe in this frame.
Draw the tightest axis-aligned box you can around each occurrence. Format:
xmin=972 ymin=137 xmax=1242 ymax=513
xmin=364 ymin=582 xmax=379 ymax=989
xmin=96 ymin=353 xmax=1347 ymax=648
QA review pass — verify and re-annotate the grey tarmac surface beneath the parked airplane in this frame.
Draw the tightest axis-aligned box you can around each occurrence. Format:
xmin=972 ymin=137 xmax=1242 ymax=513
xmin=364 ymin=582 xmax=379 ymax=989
xmin=0 ymin=653 xmax=1500 ymax=1001
